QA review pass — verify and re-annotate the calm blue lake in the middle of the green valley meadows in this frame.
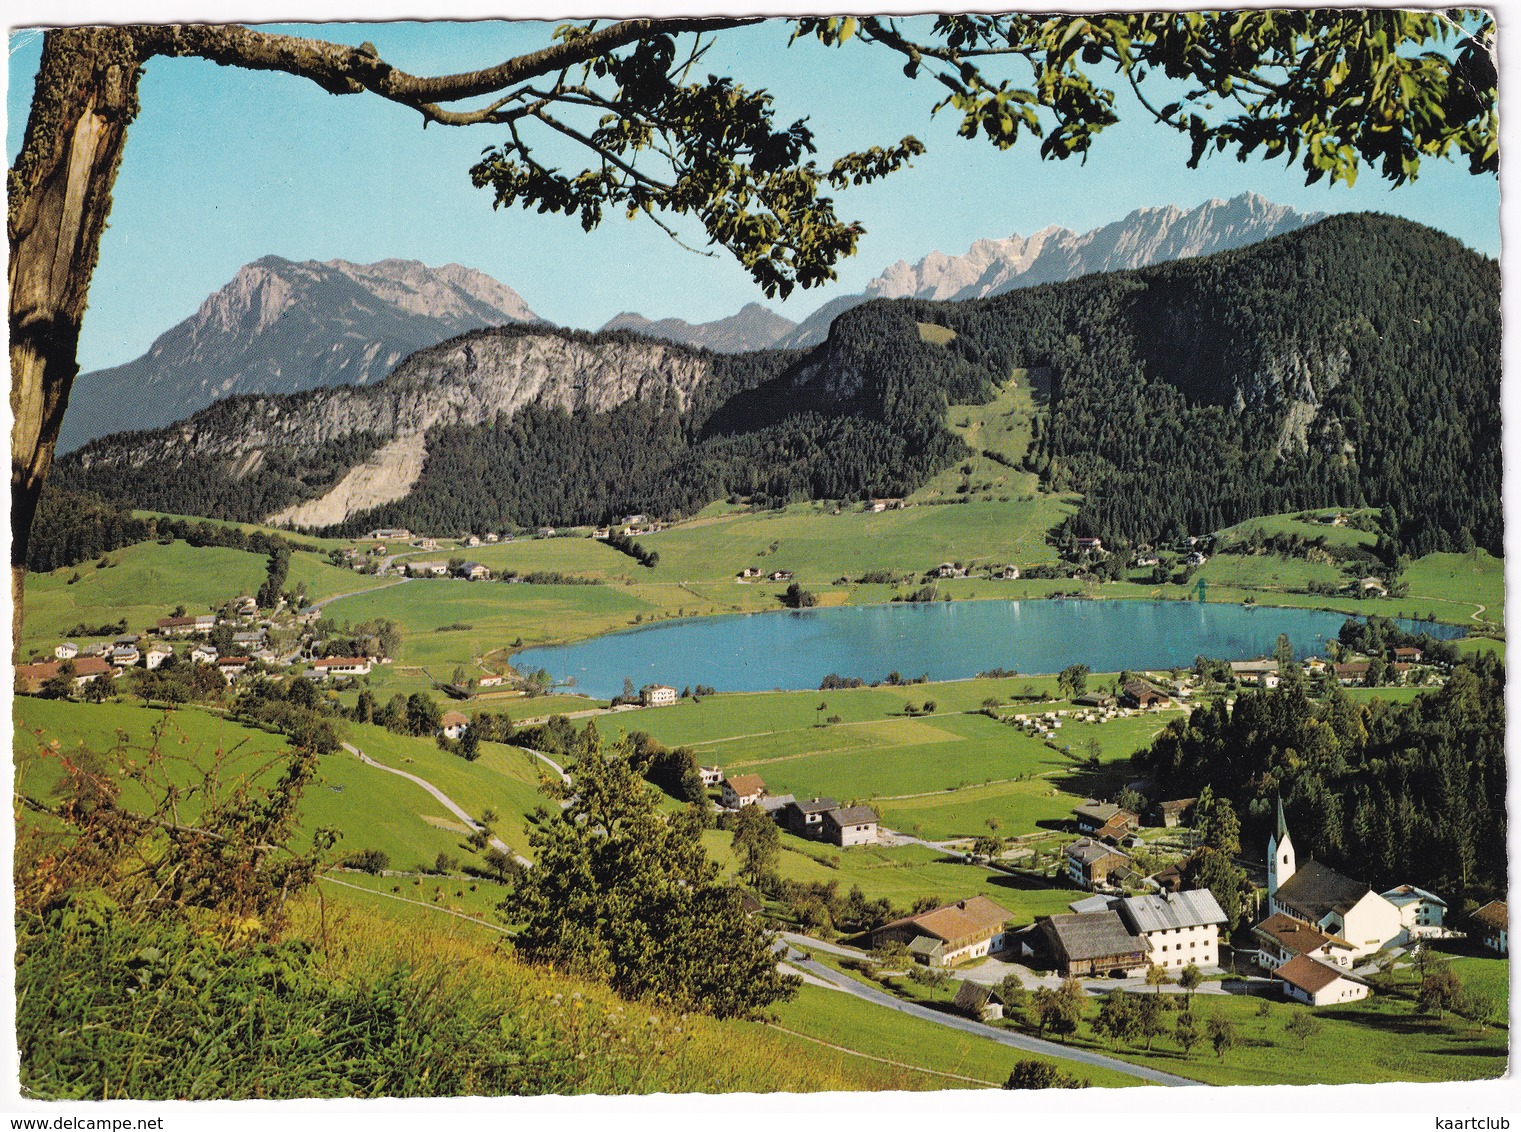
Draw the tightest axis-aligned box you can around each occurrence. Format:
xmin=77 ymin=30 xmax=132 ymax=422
xmin=513 ymin=599 xmax=1463 ymax=698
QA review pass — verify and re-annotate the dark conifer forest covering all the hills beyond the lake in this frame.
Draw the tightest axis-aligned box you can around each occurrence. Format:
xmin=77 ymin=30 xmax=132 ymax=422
xmin=55 ymin=215 xmax=1503 ymax=557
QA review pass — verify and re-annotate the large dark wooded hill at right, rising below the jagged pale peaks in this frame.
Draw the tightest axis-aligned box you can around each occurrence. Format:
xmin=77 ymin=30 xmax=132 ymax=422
xmin=857 ymin=215 xmax=1503 ymax=555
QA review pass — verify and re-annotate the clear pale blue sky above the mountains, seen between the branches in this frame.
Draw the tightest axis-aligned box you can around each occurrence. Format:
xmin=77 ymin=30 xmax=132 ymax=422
xmin=6 ymin=21 xmax=1500 ymax=370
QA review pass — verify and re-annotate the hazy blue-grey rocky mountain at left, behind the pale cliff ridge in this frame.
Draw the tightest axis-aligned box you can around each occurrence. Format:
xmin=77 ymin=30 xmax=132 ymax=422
xmin=58 ymin=256 xmax=538 ymax=452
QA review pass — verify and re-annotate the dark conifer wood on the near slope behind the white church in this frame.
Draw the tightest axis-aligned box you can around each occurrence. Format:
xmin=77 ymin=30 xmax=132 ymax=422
xmin=1132 ymin=653 xmax=1506 ymax=901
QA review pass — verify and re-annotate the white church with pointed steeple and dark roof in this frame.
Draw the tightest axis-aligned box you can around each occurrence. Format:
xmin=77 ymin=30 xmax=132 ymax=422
xmin=1267 ymin=800 xmax=1404 ymax=959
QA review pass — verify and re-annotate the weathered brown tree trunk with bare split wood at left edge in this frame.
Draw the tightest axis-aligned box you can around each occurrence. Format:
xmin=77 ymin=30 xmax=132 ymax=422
xmin=6 ymin=27 xmax=146 ymax=650
